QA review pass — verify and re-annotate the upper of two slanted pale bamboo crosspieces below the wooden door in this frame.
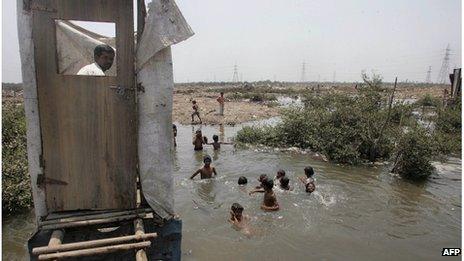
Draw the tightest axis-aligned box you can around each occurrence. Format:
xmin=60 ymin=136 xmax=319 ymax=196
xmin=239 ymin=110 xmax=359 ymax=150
xmin=32 ymin=233 xmax=156 ymax=255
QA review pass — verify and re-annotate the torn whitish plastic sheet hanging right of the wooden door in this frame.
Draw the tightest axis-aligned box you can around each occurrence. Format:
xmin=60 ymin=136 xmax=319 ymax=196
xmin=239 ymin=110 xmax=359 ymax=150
xmin=137 ymin=0 xmax=193 ymax=219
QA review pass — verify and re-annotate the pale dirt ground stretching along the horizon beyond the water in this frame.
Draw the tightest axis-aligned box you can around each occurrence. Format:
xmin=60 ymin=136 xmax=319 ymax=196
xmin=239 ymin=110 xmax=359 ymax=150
xmin=2 ymin=82 xmax=450 ymax=125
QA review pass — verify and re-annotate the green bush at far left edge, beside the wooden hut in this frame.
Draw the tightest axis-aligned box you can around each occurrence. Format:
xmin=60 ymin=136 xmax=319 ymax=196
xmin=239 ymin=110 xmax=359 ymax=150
xmin=2 ymin=101 xmax=32 ymax=215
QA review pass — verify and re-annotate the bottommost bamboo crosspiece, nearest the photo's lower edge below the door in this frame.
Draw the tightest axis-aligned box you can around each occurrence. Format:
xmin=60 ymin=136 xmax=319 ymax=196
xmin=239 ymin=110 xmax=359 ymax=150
xmin=39 ymin=241 xmax=151 ymax=260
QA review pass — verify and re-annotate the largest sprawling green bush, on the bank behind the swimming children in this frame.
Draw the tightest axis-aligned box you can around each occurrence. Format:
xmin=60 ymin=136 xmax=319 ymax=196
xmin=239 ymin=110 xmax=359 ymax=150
xmin=237 ymin=86 xmax=393 ymax=164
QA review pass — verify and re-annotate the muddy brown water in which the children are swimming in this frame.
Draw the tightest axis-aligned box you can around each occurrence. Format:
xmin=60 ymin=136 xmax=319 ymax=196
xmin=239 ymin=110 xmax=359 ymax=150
xmin=2 ymin=120 xmax=461 ymax=260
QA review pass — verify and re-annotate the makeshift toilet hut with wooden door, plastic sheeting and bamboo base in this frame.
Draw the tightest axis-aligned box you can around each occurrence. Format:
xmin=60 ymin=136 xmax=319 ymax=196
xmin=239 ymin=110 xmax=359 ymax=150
xmin=17 ymin=0 xmax=193 ymax=260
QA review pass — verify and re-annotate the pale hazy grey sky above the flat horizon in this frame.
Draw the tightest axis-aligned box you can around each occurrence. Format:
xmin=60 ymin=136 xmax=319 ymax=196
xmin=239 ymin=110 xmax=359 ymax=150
xmin=2 ymin=0 xmax=461 ymax=82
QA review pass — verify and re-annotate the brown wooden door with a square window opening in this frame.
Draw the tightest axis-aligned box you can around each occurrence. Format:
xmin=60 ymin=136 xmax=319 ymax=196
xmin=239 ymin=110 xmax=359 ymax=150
xmin=31 ymin=0 xmax=137 ymax=212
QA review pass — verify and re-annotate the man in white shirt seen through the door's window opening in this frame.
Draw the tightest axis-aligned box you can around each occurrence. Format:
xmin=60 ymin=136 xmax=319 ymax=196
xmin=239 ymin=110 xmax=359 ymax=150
xmin=77 ymin=44 xmax=115 ymax=76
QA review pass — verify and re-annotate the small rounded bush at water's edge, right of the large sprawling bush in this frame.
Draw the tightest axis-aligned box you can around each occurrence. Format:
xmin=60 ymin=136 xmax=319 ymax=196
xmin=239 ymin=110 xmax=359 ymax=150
xmin=393 ymin=127 xmax=434 ymax=180
